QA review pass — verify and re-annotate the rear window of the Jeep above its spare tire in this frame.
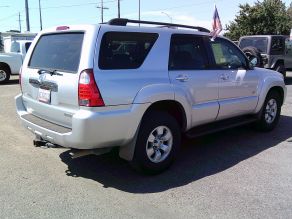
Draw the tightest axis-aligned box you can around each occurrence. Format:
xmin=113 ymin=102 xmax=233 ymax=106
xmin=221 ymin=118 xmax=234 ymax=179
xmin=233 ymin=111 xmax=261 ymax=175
xmin=239 ymin=37 xmax=268 ymax=53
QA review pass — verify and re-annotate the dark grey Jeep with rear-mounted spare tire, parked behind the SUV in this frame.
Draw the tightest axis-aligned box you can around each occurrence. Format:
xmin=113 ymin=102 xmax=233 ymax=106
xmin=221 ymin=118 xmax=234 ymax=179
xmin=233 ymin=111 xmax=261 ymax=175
xmin=238 ymin=35 xmax=292 ymax=77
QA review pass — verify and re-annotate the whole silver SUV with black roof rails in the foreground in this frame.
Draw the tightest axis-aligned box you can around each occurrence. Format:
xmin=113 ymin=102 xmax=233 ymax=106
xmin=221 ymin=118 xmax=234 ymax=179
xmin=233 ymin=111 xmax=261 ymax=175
xmin=15 ymin=19 xmax=286 ymax=173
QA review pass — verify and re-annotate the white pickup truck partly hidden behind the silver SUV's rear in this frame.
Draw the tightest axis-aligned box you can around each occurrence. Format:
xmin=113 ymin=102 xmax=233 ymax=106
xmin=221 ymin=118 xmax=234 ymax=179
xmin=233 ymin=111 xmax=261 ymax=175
xmin=0 ymin=40 xmax=32 ymax=84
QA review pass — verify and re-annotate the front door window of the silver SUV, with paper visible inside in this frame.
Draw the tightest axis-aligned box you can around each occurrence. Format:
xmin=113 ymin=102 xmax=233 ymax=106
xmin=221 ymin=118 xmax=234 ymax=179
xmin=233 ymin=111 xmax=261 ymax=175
xmin=210 ymin=38 xmax=247 ymax=69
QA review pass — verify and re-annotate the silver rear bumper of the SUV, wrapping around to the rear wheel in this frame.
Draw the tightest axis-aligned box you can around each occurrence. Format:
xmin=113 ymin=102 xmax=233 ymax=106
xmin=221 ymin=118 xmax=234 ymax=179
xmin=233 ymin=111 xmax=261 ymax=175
xmin=15 ymin=94 xmax=148 ymax=149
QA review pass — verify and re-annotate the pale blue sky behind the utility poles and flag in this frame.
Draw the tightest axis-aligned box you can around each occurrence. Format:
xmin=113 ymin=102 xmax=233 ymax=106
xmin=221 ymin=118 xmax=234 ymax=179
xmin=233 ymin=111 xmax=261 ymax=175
xmin=0 ymin=0 xmax=291 ymax=32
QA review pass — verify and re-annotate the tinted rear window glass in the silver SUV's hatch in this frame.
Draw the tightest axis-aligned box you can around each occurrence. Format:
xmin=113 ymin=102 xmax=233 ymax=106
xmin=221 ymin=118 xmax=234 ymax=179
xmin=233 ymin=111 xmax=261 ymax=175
xmin=28 ymin=33 xmax=84 ymax=73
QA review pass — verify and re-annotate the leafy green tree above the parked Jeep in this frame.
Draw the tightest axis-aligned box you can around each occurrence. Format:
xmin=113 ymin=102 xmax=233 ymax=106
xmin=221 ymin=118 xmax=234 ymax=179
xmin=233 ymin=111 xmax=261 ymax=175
xmin=225 ymin=0 xmax=292 ymax=40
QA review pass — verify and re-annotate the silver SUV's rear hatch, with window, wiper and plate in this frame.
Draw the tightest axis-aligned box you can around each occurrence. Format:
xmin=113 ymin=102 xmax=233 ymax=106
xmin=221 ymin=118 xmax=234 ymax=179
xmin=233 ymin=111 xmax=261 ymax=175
xmin=21 ymin=26 xmax=98 ymax=128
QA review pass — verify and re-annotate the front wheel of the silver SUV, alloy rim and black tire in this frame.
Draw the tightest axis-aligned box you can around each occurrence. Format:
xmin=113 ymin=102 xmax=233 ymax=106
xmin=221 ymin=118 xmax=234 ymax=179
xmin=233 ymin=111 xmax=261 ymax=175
xmin=256 ymin=91 xmax=282 ymax=132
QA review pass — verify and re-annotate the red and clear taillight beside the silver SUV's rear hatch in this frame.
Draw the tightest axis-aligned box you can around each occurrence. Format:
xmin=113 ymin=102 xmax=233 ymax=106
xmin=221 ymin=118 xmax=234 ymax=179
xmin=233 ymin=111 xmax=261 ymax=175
xmin=78 ymin=69 xmax=104 ymax=107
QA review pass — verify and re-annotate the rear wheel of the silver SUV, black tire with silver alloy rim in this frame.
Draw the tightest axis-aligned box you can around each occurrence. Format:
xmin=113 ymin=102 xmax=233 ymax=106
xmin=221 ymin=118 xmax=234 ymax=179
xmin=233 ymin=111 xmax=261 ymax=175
xmin=131 ymin=111 xmax=181 ymax=174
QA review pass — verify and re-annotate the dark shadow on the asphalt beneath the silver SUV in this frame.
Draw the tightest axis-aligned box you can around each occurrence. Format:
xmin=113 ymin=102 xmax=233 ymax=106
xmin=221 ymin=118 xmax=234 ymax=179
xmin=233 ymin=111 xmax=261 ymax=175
xmin=60 ymin=116 xmax=292 ymax=193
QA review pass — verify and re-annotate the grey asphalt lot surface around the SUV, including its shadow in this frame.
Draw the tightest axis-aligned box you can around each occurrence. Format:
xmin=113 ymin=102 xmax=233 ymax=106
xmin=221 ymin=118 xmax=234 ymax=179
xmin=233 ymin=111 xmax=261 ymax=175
xmin=0 ymin=73 xmax=292 ymax=218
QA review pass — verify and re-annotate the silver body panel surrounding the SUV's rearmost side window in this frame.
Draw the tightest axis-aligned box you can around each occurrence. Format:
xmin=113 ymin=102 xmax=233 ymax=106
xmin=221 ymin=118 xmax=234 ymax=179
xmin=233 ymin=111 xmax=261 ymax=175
xmin=94 ymin=26 xmax=173 ymax=106
